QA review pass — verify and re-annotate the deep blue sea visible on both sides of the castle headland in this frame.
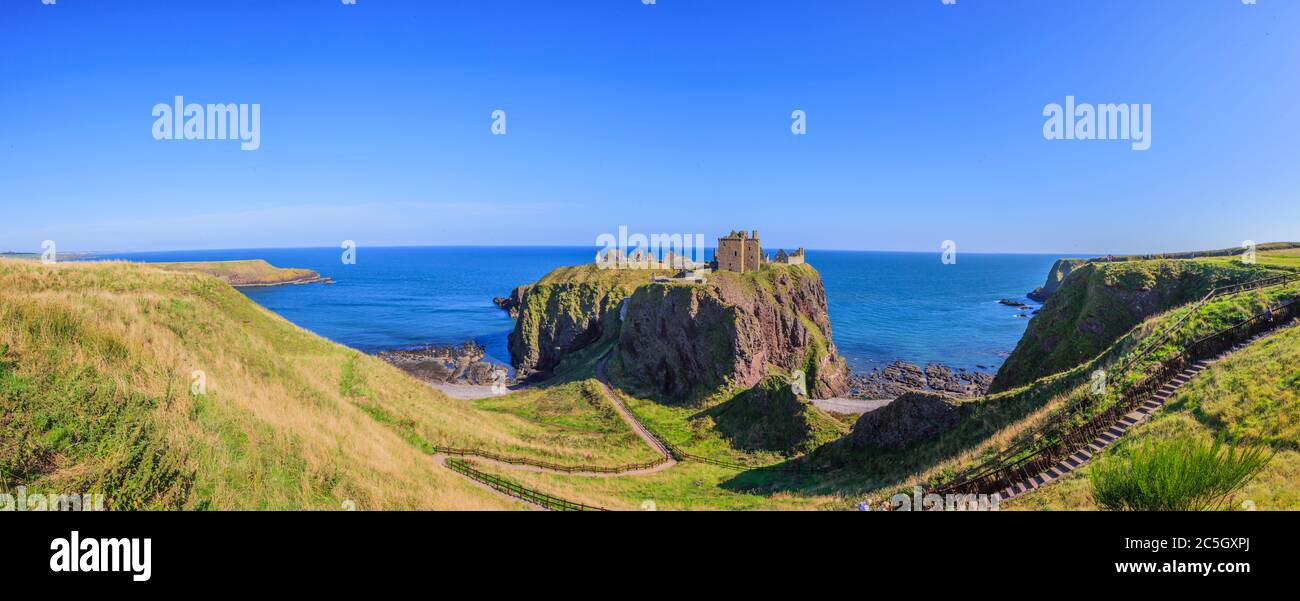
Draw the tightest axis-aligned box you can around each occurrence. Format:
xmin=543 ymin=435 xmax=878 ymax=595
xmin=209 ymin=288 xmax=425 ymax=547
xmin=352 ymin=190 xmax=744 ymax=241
xmin=101 ymin=247 xmax=1063 ymax=371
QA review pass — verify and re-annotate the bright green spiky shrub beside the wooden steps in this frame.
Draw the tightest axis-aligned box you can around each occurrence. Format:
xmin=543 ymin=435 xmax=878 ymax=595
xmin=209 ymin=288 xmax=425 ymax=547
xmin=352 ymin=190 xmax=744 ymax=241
xmin=1091 ymin=437 xmax=1273 ymax=511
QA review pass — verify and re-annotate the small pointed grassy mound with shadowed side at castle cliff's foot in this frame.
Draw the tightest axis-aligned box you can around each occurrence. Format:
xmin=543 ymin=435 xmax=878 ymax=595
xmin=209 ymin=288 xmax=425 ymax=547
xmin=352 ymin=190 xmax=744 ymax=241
xmin=698 ymin=376 xmax=848 ymax=455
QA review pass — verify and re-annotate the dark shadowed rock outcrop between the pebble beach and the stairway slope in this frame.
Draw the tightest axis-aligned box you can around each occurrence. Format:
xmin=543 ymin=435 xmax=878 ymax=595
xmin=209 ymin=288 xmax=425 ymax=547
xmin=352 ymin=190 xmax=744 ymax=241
xmin=849 ymin=393 xmax=961 ymax=450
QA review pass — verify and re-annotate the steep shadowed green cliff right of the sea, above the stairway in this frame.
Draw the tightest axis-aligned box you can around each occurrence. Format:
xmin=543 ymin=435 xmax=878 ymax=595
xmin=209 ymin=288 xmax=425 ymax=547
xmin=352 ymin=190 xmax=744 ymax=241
xmin=989 ymin=259 xmax=1277 ymax=392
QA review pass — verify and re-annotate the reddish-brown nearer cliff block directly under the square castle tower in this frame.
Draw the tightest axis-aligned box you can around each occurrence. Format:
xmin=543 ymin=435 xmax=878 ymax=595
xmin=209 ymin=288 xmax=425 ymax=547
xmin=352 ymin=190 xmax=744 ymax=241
xmin=619 ymin=265 xmax=849 ymax=401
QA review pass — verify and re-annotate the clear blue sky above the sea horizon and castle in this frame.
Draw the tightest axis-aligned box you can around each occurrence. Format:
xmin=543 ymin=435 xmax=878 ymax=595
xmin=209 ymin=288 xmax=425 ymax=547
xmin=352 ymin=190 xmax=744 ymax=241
xmin=0 ymin=0 xmax=1300 ymax=252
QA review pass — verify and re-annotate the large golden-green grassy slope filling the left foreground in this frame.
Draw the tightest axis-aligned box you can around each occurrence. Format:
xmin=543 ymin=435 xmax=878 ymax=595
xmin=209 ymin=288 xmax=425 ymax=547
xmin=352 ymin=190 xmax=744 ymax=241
xmin=0 ymin=259 xmax=641 ymax=510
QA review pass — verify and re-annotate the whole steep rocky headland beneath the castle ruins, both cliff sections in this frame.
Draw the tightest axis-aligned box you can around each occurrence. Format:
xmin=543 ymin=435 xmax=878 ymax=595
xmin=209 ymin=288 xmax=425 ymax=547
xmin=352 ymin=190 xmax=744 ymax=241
xmin=510 ymin=265 xmax=849 ymax=401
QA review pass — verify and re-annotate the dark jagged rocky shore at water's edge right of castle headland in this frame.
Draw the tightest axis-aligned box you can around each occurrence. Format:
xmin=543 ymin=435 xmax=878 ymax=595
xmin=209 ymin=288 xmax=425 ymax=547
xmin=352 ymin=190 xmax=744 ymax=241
xmin=849 ymin=360 xmax=993 ymax=398
